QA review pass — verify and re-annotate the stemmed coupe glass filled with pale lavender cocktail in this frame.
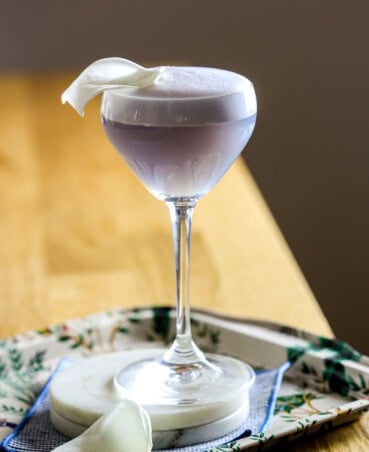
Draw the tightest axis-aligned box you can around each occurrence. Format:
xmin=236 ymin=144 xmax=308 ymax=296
xmin=101 ymin=67 xmax=256 ymax=420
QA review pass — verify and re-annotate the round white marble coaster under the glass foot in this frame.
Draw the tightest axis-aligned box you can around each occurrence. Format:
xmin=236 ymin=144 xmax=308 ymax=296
xmin=50 ymin=349 xmax=254 ymax=448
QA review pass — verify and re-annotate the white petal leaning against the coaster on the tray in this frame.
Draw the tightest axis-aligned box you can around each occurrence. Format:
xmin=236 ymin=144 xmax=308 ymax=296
xmin=54 ymin=399 xmax=152 ymax=452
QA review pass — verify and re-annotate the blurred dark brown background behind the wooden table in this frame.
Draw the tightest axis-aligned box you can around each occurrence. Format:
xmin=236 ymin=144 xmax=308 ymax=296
xmin=0 ymin=0 xmax=369 ymax=353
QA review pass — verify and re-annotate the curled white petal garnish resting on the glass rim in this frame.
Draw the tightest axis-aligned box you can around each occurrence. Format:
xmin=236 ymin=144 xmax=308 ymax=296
xmin=61 ymin=57 xmax=164 ymax=116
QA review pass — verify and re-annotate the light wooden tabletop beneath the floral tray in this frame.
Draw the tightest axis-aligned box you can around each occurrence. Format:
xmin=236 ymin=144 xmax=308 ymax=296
xmin=0 ymin=74 xmax=369 ymax=452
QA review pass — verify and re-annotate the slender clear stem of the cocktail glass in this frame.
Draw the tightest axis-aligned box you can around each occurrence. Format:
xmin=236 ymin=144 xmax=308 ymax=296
xmin=163 ymin=198 xmax=205 ymax=366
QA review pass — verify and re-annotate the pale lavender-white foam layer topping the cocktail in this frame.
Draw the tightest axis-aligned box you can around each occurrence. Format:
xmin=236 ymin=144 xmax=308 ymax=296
xmin=102 ymin=67 xmax=257 ymax=125
